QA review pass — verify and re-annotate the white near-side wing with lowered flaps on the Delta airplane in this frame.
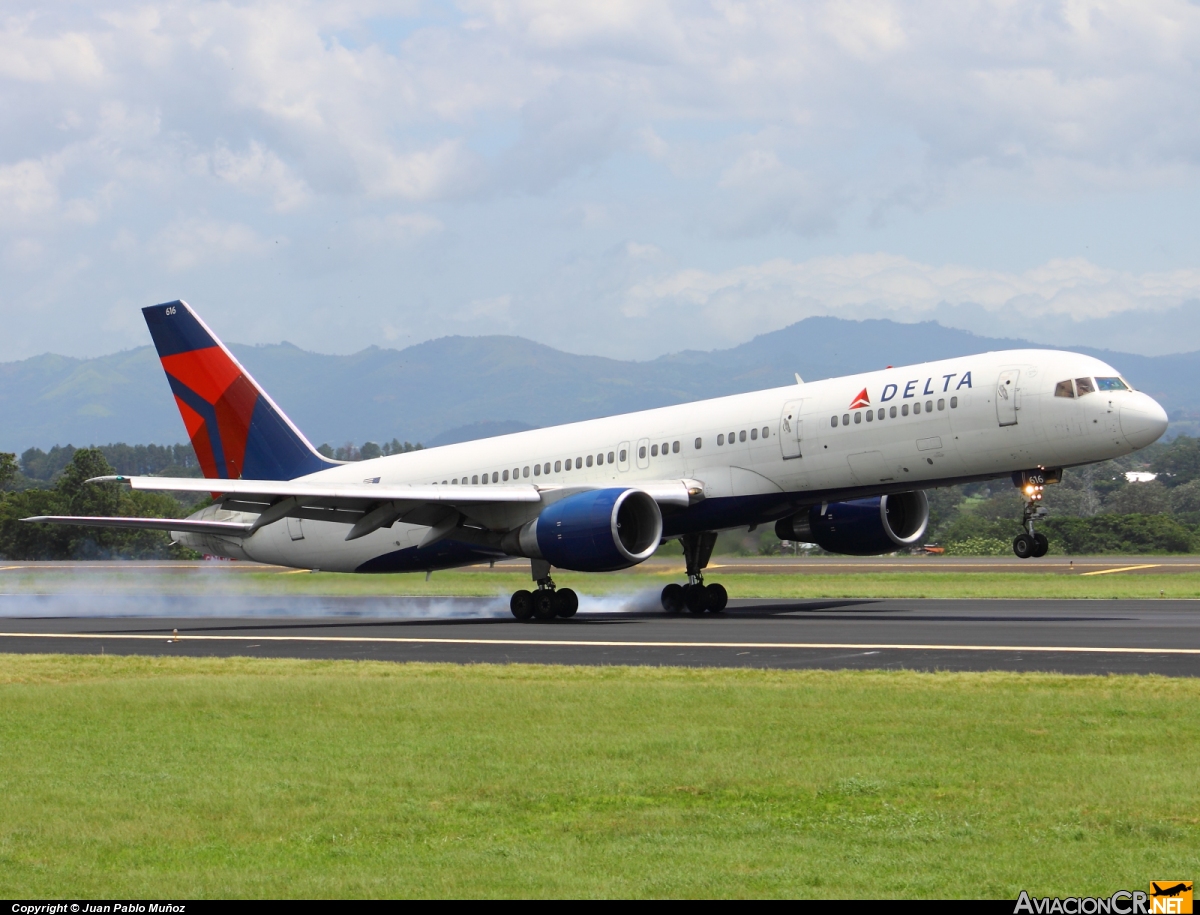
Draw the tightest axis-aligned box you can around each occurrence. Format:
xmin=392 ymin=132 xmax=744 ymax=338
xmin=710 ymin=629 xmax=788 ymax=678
xmin=65 ymin=477 xmax=703 ymax=540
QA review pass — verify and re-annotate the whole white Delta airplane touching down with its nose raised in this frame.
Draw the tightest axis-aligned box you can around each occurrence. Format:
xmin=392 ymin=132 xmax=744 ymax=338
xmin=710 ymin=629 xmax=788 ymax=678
xmin=24 ymin=300 xmax=1168 ymax=620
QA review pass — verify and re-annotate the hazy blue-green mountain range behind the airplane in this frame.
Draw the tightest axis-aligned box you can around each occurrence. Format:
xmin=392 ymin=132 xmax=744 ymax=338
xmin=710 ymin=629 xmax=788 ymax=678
xmin=0 ymin=317 xmax=1200 ymax=453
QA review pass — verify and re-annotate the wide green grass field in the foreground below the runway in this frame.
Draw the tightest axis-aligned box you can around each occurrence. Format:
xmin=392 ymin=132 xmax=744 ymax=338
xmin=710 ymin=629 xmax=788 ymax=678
xmin=0 ymin=656 xmax=1200 ymax=898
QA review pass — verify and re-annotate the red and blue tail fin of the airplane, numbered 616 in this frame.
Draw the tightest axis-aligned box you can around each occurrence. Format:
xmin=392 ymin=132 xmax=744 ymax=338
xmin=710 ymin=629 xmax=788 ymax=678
xmin=142 ymin=301 xmax=336 ymax=480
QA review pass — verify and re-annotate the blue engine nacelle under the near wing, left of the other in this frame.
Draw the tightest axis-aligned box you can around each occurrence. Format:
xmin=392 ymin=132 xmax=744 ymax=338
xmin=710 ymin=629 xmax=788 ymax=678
xmin=517 ymin=489 xmax=662 ymax=572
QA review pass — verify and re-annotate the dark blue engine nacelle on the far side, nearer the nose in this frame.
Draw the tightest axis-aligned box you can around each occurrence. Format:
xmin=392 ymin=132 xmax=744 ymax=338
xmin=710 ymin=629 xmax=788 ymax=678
xmin=775 ymin=490 xmax=929 ymax=556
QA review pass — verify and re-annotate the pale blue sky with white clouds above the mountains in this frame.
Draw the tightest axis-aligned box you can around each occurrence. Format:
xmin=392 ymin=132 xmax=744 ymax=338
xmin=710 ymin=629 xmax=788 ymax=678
xmin=0 ymin=0 xmax=1200 ymax=360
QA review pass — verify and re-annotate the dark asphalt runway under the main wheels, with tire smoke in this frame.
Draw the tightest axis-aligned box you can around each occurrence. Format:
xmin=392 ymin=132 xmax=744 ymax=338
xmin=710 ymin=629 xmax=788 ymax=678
xmin=0 ymin=594 xmax=1200 ymax=676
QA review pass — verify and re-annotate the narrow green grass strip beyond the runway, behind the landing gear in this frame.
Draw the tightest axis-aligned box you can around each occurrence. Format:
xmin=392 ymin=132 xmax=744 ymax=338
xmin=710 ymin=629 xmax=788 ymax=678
xmin=9 ymin=558 xmax=1200 ymax=599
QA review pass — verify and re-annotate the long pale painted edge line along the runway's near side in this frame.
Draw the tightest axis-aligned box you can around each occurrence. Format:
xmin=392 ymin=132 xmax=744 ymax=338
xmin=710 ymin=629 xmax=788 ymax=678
xmin=0 ymin=633 xmax=1200 ymax=656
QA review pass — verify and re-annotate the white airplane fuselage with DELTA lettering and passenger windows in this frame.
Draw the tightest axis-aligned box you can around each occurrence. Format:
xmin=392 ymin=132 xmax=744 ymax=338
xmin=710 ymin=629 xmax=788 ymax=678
xmin=176 ymin=349 xmax=1166 ymax=572
